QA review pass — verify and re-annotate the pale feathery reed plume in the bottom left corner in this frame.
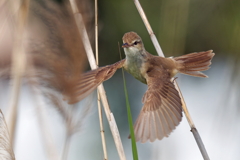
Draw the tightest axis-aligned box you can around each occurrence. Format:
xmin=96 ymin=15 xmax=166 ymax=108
xmin=0 ymin=109 xmax=15 ymax=160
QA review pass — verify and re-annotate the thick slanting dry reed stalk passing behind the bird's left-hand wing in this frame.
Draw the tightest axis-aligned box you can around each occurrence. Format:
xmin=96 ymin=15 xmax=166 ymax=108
xmin=70 ymin=0 xmax=126 ymax=160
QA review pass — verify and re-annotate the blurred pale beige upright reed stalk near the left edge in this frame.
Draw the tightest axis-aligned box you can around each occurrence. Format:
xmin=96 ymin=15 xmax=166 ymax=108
xmin=7 ymin=0 xmax=29 ymax=145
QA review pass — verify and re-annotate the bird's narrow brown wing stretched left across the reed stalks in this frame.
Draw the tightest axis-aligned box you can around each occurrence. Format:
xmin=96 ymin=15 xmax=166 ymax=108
xmin=64 ymin=59 xmax=125 ymax=104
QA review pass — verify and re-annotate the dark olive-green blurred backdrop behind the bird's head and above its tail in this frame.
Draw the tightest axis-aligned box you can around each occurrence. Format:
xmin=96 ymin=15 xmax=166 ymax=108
xmin=95 ymin=0 xmax=240 ymax=66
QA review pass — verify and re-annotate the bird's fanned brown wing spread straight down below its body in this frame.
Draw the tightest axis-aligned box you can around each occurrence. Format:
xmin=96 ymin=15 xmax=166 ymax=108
xmin=134 ymin=67 xmax=182 ymax=143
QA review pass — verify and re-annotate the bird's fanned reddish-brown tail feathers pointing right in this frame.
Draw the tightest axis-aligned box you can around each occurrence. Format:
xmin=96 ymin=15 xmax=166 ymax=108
xmin=174 ymin=50 xmax=215 ymax=77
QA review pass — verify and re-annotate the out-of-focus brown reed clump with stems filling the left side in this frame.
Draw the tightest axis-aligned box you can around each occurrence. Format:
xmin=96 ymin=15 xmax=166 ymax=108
xmin=0 ymin=0 xmax=93 ymax=159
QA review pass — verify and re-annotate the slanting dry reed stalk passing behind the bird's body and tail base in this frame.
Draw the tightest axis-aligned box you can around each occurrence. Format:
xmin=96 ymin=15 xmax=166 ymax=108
xmin=133 ymin=0 xmax=210 ymax=160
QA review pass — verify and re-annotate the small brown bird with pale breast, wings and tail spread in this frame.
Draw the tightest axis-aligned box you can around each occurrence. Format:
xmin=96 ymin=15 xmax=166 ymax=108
xmin=64 ymin=31 xmax=215 ymax=143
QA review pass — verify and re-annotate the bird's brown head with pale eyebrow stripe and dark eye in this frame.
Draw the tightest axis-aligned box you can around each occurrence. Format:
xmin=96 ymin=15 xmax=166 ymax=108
xmin=122 ymin=32 xmax=144 ymax=54
